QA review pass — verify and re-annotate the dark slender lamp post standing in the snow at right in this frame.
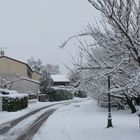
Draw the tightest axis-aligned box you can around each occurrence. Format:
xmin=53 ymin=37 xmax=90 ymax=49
xmin=107 ymin=76 xmax=113 ymax=128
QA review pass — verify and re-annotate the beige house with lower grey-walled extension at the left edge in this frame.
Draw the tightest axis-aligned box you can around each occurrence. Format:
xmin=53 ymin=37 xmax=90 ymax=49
xmin=0 ymin=54 xmax=41 ymax=94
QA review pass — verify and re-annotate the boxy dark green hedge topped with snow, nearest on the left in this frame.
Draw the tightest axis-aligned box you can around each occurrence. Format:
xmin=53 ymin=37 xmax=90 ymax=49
xmin=2 ymin=95 xmax=28 ymax=112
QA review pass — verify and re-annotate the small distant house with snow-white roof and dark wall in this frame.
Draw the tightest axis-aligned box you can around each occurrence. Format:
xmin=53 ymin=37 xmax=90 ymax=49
xmin=51 ymin=75 xmax=70 ymax=86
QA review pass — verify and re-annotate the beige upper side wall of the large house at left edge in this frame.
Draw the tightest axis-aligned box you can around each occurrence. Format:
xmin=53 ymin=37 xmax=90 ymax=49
xmin=0 ymin=57 xmax=28 ymax=77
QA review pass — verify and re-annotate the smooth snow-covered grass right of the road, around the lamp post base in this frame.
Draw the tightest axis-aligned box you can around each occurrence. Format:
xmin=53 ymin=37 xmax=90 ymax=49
xmin=33 ymin=100 xmax=140 ymax=140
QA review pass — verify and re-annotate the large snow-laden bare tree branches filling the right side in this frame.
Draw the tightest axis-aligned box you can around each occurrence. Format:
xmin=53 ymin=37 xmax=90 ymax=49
xmin=61 ymin=0 xmax=140 ymax=112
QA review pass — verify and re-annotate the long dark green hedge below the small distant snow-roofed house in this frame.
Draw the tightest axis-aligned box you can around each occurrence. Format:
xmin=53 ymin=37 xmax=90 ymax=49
xmin=49 ymin=89 xmax=73 ymax=101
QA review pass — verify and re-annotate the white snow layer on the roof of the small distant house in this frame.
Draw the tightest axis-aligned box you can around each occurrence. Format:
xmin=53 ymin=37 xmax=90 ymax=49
xmin=51 ymin=75 xmax=70 ymax=82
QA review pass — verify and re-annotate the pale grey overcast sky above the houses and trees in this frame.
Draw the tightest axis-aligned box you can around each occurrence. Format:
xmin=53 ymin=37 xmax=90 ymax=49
xmin=0 ymin=0 xmax=98 ymax=73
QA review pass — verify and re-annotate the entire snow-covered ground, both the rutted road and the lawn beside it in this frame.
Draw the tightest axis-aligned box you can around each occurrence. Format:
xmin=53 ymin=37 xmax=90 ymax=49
xmin=0 ymin=98 xmax=140 ymax=140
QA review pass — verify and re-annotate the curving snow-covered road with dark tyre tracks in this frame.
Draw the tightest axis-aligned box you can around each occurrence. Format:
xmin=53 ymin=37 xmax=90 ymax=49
xmin=0 ymin=100 xmax=83 ymax=140
